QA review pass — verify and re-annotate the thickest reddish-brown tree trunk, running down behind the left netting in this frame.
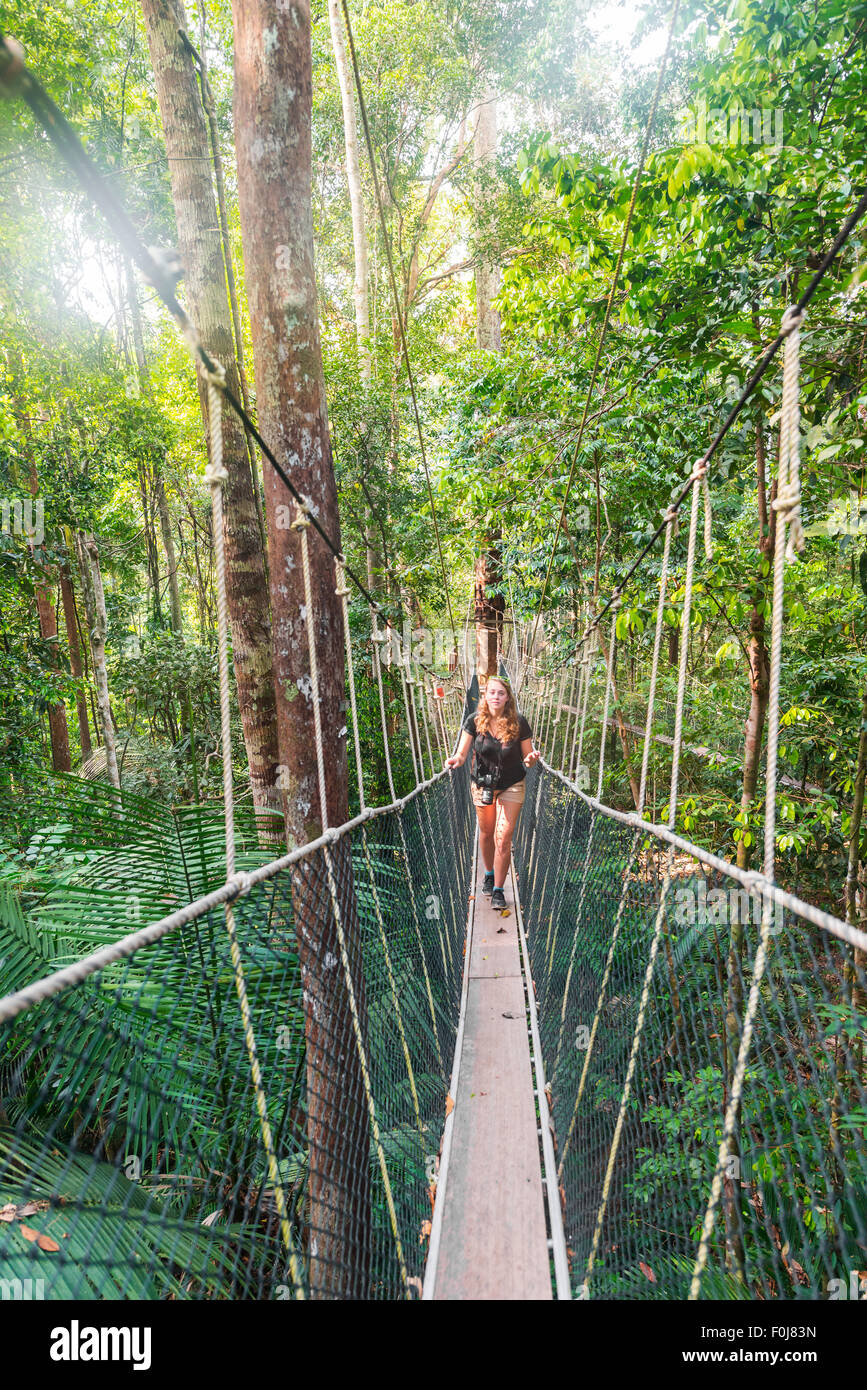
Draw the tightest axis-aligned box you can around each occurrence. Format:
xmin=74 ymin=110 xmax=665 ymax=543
xmin=233 ymin=0 xmax=371 ymax=1298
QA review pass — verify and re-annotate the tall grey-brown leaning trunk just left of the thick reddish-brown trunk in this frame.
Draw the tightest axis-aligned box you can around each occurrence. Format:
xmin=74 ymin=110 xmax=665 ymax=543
xmin=142 ymin=0 xmax=277 ymax=813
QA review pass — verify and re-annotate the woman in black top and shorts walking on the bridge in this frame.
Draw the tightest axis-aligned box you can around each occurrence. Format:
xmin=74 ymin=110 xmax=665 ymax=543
xmin=446 ymin=676 xmax=542 ymax=908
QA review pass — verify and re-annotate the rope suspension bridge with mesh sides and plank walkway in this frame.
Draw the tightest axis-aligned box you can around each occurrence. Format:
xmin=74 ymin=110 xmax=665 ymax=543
xmin=0 ymin=29 xmax=867 ymax=1300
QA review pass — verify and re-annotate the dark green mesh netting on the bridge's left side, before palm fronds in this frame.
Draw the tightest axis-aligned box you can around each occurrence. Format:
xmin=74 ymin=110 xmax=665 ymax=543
xmin=0 ymin=777 xmax=472 ymax=1300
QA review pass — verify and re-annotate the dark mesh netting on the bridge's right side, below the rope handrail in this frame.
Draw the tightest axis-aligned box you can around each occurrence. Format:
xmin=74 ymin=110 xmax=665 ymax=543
xmin=514 ymin=765 xmax=867 ymax=1300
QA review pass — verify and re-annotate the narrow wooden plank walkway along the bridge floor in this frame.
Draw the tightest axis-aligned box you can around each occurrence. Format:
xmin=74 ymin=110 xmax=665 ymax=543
xmin=428 ymin=855 xmax=553 ymax=1300
